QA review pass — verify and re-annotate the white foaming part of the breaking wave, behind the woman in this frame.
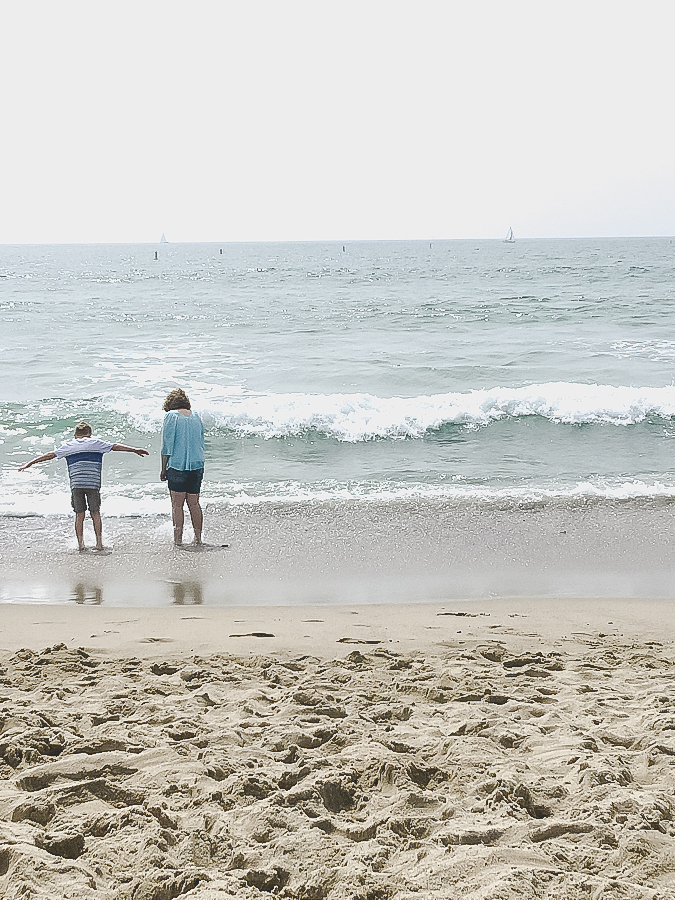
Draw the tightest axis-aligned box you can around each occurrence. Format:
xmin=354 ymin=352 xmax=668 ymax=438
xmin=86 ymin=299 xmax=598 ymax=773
xmin=114 ymin=382 xmax=675 ymax=443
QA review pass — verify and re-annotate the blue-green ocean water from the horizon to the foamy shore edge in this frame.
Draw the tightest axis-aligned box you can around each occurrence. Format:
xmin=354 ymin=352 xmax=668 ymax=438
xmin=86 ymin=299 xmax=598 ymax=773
xmin=0 ymin=238 xmax=675 ymax=517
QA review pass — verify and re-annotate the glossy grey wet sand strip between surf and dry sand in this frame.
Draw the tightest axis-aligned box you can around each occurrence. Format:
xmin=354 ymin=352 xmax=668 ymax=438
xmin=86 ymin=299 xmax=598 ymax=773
xmin=0 ymin=502 xmax=675 ymax=607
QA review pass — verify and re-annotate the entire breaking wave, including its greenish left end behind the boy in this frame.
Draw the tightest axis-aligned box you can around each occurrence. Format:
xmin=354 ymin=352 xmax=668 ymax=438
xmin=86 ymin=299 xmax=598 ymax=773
xmin=5 ymin=381 xmax=675 ymax=444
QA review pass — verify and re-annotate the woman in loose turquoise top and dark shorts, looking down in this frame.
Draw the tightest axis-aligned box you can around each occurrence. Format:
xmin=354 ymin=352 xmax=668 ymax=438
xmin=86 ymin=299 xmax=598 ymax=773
xmin=159 ymin=390 xmax=204 ymax=547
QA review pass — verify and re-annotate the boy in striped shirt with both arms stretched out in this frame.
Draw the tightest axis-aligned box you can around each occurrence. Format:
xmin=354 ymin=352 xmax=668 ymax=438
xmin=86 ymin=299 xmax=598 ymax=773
xmin=19 ymin=422 xmax=148 ymax=550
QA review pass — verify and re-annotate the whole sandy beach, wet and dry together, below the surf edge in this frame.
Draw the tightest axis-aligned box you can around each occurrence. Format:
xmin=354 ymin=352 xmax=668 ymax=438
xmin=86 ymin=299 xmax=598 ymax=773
xmin=0 ymin=504 xmax=675 ymax=900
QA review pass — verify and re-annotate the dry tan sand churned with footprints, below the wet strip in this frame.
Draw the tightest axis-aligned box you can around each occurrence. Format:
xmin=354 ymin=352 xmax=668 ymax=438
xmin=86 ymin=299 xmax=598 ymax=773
xmin=0 ymin=598 xmax=675 ymax=900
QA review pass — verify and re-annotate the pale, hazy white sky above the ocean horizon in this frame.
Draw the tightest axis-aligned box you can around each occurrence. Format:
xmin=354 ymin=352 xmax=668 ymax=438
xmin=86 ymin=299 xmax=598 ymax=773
xmin=0 ymin=0 xmax=675 ymax=243
